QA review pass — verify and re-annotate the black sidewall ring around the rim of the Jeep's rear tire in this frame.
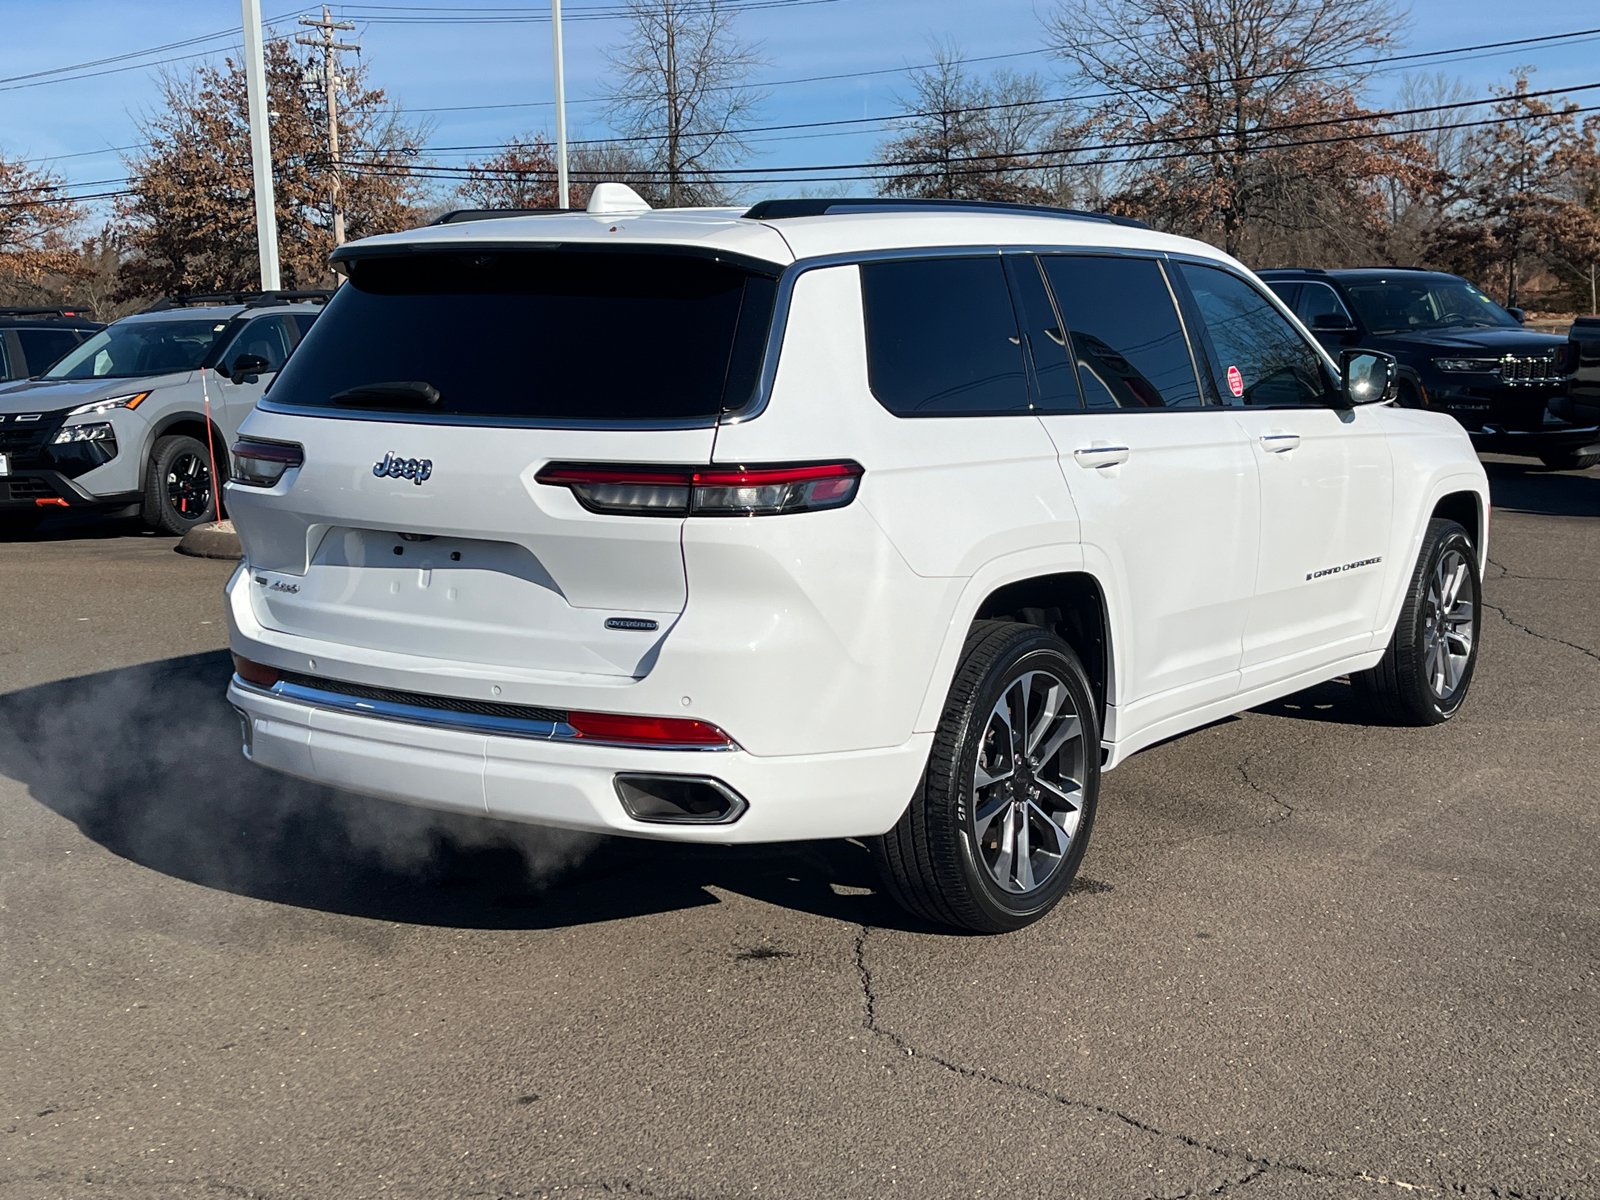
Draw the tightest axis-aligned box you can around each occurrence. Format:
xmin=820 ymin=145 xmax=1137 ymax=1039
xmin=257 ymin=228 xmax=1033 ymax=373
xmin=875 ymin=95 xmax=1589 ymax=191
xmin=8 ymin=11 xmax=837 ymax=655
xmin=949 ymin=640 xmax=1099 ymax=930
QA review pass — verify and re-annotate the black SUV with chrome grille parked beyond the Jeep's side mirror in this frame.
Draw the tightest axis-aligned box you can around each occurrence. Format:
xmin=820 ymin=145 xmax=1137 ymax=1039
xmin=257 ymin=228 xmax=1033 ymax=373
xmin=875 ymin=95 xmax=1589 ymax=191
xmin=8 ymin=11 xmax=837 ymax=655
xmin=1259 ymin=267 xmax=1600 ymax=470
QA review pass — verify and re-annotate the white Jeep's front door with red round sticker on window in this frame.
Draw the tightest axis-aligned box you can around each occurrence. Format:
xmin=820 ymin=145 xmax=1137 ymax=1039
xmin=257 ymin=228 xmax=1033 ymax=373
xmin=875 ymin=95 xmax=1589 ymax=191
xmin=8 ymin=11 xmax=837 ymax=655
xmin=1178 ymin=262 xmax=1394 ymax=691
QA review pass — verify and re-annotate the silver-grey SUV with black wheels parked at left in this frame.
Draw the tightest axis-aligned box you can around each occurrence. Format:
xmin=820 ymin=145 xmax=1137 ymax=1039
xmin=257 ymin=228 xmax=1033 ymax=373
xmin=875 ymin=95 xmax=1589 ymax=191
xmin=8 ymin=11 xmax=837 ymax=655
xmin=0 ymin=291 xmax=328 ymax=534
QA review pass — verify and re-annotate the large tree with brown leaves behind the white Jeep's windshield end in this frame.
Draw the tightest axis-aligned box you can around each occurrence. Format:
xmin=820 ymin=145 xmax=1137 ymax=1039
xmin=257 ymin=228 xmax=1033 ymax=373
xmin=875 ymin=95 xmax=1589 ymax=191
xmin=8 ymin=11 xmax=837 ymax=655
xmin=1046 ymin=0 xmax=1427 ymax=261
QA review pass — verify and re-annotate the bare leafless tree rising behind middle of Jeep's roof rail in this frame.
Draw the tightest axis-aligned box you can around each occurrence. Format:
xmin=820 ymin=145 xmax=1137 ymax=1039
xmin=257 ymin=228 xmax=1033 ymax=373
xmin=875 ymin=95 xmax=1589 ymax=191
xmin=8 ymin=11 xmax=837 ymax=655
xmin=877 ymin=43 xmax=1078 ymax=203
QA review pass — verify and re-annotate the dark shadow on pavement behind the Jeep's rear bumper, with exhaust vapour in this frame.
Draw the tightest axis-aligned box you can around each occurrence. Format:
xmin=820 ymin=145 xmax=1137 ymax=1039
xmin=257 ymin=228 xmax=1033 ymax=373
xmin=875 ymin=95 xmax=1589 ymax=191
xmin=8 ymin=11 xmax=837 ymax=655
xmin=0 ymin=651 xmax=931 ymax=931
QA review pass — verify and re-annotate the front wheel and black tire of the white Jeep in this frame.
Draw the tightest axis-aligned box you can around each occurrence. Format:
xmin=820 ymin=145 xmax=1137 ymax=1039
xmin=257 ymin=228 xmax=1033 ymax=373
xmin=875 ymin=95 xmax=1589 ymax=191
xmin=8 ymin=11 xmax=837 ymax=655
xmin=1350 ymin=517 xmax=1483 ymax=725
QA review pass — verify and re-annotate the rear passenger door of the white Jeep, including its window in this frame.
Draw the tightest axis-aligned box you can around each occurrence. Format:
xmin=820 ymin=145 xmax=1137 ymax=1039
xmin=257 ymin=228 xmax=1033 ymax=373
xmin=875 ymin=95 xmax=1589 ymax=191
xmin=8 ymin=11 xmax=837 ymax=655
xmin=1013 ymin=254 xmax=1259 ymax=741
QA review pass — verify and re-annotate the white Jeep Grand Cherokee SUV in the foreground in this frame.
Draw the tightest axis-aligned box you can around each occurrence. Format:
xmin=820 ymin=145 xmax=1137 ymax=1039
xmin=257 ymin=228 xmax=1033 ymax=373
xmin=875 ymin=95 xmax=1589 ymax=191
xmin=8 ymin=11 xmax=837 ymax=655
xmin=227 ymin=186 xmax=1490 ymax=931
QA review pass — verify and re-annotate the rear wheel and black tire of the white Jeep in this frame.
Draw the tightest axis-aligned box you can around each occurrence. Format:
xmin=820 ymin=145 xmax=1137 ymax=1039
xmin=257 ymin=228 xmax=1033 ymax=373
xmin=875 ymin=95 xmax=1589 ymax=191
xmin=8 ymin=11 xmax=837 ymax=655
xmin=872 ymin=621 xmax=1101 ymax=933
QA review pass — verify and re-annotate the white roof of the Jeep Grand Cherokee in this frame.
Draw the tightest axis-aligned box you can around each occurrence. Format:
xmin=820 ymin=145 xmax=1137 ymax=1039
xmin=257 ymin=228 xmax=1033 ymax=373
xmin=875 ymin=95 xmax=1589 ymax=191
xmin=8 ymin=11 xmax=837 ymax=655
xmin=339 ymin=208 xmax=1234 ymax=275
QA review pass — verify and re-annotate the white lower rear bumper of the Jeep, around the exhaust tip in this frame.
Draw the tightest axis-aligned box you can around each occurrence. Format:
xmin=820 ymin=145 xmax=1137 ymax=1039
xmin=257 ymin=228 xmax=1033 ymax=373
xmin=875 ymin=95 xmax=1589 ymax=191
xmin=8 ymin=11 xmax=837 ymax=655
xmin=227 ymin=680 xmax=933 ymax=843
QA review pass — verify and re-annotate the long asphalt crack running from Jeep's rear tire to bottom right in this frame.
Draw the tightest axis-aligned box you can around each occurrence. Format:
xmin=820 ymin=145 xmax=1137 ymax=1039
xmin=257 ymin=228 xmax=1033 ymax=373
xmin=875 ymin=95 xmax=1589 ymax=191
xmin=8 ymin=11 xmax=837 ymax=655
xmin=854 ymin=928 xmax=1574 ymax=1200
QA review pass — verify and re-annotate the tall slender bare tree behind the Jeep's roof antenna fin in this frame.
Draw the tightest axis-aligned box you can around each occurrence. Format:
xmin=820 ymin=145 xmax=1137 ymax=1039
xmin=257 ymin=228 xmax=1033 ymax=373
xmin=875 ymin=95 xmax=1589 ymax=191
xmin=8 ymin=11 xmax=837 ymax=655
xmin=606 ymin=0 xmax=765 ymax=208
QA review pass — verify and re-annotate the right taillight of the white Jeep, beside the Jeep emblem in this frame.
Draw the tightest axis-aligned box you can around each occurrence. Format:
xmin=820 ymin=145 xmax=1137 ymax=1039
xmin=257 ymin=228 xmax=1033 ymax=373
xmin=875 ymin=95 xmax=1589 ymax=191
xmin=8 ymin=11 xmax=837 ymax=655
xmin=534 ymin=462 xmax=862 ymax=517
